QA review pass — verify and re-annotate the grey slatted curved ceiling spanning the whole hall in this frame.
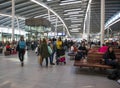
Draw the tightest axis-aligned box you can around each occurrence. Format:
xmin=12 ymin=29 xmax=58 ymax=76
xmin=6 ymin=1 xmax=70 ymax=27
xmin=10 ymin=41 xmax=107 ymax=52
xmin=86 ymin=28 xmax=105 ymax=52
xmin=0 ymin=0 xmax=120 ymax=37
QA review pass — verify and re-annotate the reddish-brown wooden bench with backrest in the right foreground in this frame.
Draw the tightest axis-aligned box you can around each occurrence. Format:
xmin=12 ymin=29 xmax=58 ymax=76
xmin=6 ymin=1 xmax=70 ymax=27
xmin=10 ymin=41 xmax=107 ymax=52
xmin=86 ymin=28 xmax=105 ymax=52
xmin=74 ymin=53 xmax=112 ymax=69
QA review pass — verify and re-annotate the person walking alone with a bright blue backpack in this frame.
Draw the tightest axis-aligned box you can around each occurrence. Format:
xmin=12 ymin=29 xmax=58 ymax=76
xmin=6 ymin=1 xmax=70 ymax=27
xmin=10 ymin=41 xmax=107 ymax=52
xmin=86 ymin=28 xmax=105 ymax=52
xmin=17 ymin=36 xmax=26 ymax=67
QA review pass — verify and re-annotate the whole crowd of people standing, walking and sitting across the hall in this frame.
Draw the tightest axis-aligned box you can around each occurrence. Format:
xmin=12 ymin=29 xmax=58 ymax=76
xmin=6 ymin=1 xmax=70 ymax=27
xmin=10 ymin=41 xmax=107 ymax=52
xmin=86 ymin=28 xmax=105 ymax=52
xmin=0 ymin=36 xmax=120 ymax=84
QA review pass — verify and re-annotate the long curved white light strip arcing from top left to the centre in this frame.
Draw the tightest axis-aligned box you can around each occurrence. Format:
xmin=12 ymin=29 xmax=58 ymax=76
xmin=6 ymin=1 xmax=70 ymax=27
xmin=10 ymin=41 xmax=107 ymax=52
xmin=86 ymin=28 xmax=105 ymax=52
xmin=31 ymin=0 xmax=71 ymax=36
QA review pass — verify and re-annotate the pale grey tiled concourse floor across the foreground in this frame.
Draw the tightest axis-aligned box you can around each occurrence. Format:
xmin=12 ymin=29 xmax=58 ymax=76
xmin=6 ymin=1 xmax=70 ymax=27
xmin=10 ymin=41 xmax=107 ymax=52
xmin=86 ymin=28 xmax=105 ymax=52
xmin=0 ymin=51 xmax=120 ymax=88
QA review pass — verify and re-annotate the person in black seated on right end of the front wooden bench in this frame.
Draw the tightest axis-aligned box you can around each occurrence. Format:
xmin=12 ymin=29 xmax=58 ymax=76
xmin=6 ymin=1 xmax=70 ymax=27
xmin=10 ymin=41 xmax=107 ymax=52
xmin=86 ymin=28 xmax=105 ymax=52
xmin=103 ymin=47 xmax=119 ymax=68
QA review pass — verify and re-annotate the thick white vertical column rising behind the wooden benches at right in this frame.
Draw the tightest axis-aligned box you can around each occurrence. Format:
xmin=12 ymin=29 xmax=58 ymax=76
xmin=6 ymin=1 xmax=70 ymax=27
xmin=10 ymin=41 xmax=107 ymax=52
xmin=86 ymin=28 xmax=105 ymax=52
xmin=101 ymin=0 xmax=105 ymax=46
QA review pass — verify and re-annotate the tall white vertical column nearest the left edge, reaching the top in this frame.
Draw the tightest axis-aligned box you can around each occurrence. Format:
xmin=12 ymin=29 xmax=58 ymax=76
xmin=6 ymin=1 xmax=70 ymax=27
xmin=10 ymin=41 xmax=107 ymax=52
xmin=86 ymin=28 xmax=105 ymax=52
xmin=12 ymin=0 xmax=15 ymax=41
